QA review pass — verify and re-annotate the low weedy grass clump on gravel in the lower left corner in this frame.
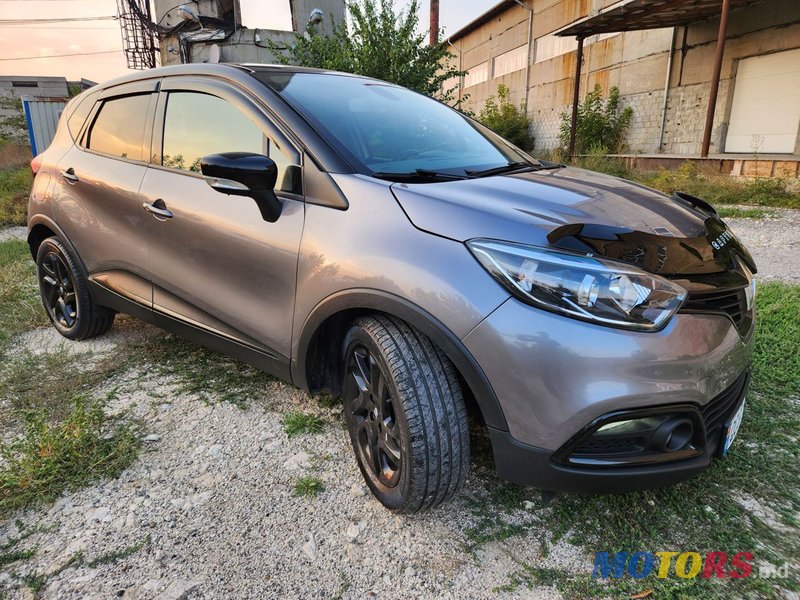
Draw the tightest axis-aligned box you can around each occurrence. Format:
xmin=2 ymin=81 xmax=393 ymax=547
xmin=0 ymin=397 xmax=141 ymax=513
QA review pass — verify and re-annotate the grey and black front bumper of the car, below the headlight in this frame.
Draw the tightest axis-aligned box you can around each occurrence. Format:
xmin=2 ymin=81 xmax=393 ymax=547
xmin=464 ymin=299 xmax=753 ymax=492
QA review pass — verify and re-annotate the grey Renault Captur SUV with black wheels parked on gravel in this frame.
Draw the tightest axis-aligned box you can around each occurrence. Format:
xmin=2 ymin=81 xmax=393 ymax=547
xmin=28 ymin=65 xmax=756 ymax=512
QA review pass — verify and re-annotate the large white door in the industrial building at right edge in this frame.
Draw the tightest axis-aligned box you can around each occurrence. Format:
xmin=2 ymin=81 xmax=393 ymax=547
xmin=725 ymin=50 xmax=800 ymax=154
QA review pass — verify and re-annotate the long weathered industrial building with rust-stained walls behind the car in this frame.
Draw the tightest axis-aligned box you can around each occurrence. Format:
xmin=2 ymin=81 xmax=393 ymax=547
xmin=447 ymin=0 xmax=800 ymax=177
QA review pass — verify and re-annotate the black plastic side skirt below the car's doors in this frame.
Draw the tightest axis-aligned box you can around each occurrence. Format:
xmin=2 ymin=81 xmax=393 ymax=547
xmin=89 ymin=280 xmax=292 ymax=383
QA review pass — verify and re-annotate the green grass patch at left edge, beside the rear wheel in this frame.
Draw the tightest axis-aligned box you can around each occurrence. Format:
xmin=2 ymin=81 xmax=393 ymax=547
xmin=0 ymin=240 xmax=48 ymax=350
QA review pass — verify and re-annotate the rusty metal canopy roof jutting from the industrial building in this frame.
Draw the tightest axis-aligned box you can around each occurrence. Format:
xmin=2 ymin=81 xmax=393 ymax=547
xmin=554 ymin=0 xmax=763 ymax=37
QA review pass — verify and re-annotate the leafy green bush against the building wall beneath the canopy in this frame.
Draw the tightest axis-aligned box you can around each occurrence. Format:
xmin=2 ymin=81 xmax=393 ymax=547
xmin=559 ymin=84 xmax=633 ymax=154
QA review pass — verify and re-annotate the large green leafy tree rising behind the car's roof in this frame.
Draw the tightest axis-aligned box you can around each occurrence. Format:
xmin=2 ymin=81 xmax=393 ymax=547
xmin=268 ymin=0 xmax=463 ymax=102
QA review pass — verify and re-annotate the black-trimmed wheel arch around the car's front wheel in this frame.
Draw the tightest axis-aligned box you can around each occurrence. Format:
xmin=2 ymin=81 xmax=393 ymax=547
xmin=292 ymin=290 xmax=508 ymax=431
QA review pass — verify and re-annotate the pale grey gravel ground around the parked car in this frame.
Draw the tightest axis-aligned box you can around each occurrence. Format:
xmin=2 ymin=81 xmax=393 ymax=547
xmin=0 ymin=211 xmax=800 ymax=599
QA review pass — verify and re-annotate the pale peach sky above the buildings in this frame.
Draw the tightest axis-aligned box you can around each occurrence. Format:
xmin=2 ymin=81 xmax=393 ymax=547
xmin=0 ymin=0 xmax=496 ymax=81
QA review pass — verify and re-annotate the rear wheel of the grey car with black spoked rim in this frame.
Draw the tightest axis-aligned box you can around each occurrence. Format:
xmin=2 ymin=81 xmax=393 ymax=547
xmin=36 ymin=237 xmax=115 ymax=340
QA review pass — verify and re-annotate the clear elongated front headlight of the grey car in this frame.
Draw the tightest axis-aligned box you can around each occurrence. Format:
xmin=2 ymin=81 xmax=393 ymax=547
xmin=467 ymin=239 xmax=686 ymax=330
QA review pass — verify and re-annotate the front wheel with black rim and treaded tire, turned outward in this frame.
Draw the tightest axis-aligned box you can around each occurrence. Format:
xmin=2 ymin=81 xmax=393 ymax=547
xmin=342 ymin=315 xmax=469 ymax=513
